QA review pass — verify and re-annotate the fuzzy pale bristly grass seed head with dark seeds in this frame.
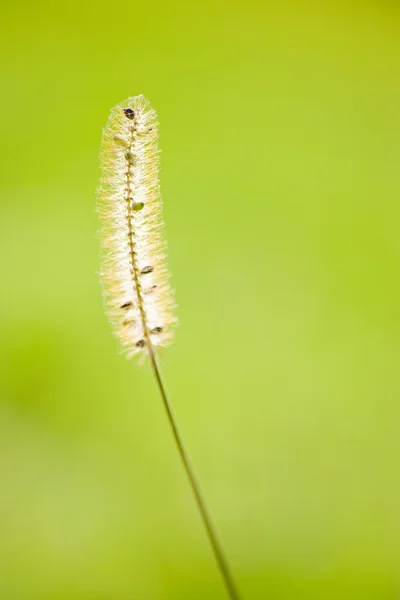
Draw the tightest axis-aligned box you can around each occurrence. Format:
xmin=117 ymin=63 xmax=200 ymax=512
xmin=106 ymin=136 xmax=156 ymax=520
xmin=99 ymin=96 xmax=176 ymax=356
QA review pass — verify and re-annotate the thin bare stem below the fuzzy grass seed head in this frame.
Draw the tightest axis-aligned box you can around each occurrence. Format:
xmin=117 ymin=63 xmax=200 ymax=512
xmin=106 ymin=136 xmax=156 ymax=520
xmin=147 ymin=340 xmax=241 ymax=600
